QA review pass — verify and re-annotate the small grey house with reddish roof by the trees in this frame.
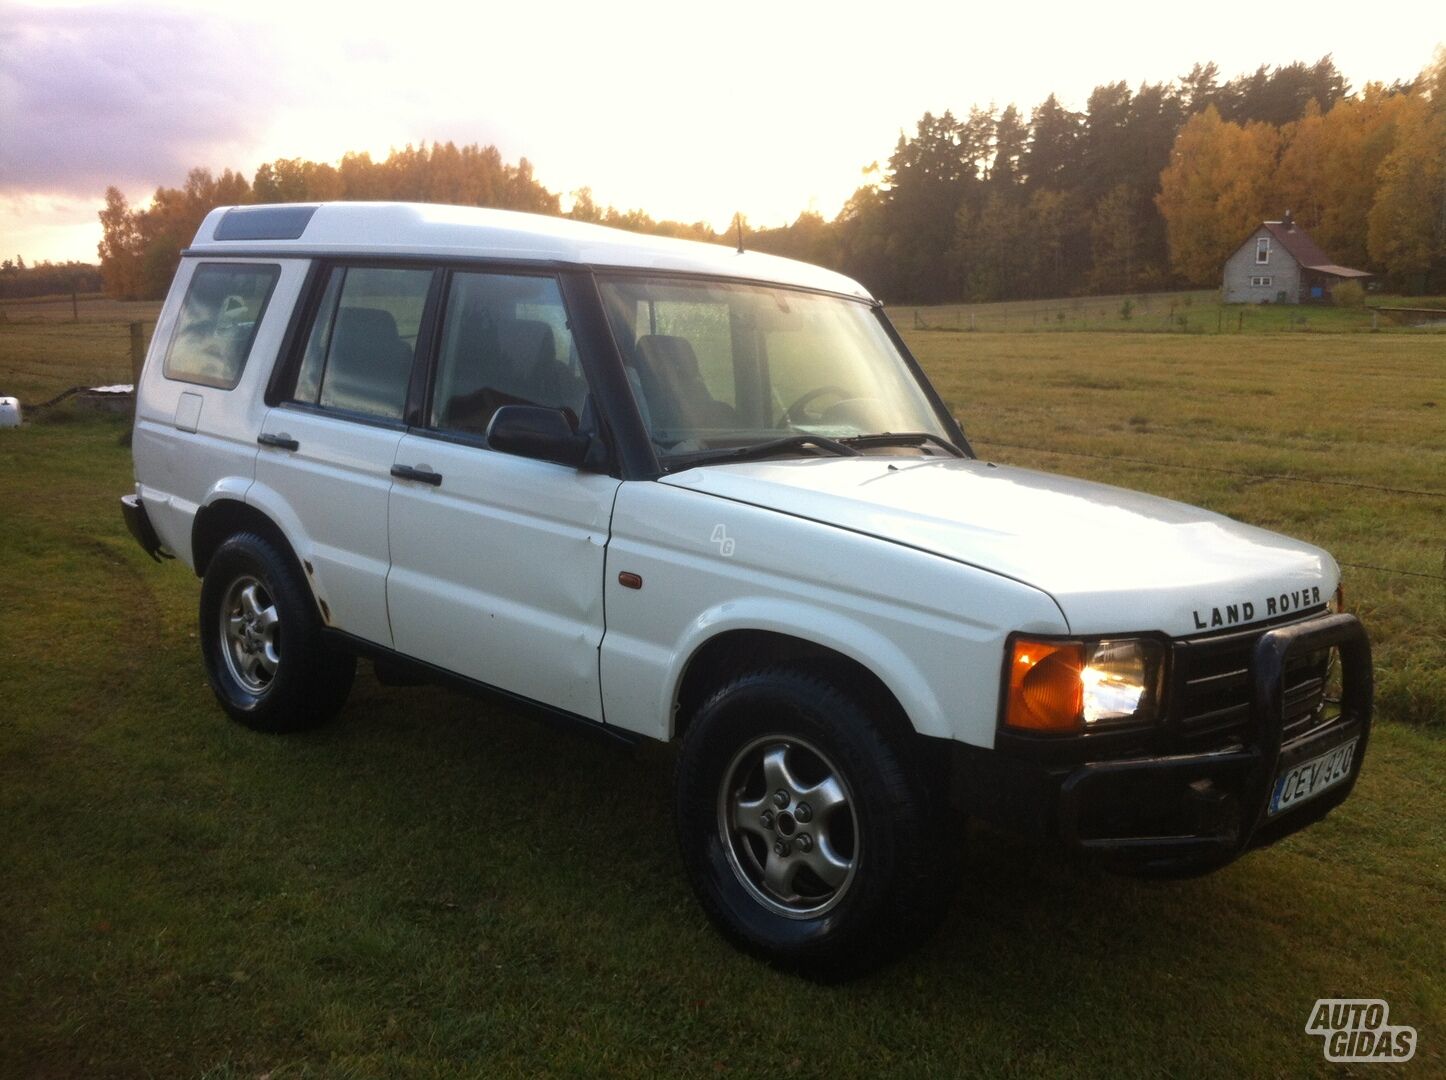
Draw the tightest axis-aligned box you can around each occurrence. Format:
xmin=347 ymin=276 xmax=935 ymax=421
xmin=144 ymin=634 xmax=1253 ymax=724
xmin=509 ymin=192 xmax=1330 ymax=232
xmin=1220 ymin=210 xmax=1371 ymax=304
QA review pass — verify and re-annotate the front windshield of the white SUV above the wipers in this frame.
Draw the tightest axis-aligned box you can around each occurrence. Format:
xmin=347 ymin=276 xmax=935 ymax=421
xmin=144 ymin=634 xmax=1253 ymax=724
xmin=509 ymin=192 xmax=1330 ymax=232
xmin=602 ymin=278 xmax=949 ymax=464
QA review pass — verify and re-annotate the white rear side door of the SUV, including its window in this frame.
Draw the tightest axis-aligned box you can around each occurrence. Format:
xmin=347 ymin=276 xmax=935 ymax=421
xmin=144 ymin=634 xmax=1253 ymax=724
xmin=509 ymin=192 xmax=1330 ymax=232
xmin=256 ymin=265 xmax=440 ymax=646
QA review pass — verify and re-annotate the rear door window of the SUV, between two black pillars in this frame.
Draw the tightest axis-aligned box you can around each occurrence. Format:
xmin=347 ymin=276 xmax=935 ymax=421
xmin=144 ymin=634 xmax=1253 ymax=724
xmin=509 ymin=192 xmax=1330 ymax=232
xmin=292 ymin=266 xmax=432 ymax=419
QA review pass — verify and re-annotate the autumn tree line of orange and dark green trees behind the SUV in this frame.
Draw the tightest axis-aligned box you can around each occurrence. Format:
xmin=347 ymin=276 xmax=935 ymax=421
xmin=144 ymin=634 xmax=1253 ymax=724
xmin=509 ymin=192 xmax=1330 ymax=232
xmin=100 ymin=53 xmax=1446 ymax=304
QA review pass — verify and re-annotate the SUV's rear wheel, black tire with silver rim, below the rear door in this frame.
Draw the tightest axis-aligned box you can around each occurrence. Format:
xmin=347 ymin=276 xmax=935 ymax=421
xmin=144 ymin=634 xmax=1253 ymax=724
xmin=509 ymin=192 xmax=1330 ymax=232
xmin=200 ymin=532 xmax=356 ymax=733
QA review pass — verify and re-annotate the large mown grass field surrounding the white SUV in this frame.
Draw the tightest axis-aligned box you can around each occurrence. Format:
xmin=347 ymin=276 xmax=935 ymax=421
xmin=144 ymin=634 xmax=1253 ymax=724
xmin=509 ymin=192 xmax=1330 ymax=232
xmin=0 ymin=293 xmax=1446 ymax=1080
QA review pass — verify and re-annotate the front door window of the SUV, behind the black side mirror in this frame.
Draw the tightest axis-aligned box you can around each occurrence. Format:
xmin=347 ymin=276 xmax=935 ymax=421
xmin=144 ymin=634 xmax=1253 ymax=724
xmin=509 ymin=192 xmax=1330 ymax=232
xmin=431 ymin=273 xmax=587 ymax=435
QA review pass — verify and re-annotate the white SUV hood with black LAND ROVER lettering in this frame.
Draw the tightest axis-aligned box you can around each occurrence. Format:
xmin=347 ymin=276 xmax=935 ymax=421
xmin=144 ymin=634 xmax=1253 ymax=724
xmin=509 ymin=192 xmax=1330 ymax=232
xmin=662 ymin=455 xmax=1339 ymax=636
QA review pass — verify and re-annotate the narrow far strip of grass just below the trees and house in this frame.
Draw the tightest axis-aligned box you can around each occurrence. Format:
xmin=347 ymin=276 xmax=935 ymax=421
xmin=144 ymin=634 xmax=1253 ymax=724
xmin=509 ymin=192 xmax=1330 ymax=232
xmin=889 ymin=289 xmax=1446 ymax=334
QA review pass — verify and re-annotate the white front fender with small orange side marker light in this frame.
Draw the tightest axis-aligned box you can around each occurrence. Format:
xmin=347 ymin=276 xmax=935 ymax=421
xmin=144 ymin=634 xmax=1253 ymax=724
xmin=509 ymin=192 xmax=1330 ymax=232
xmin=599 ymin=481 xmax=1069 ymax=746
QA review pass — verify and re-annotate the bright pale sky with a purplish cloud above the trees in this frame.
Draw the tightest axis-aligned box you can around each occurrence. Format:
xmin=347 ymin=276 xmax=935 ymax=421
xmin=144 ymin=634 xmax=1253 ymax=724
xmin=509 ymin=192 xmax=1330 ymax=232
xmin=0 ymin=0 xmax=1446 ymax=260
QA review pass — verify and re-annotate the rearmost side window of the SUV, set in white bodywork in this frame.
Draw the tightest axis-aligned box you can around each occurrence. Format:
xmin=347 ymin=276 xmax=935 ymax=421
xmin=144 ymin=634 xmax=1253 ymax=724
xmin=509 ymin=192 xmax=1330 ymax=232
xmin=165 ymin=263 xmax=281 ymax=390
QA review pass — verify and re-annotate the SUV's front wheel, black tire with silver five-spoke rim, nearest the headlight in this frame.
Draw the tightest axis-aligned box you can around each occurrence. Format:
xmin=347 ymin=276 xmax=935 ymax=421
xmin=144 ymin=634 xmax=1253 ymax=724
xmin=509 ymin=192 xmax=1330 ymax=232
xmin=675 ymin=667 xmax=957 ymax=980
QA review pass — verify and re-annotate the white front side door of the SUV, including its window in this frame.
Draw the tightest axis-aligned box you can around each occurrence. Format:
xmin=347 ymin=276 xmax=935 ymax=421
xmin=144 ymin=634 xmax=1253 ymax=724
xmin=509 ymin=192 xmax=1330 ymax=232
xmin=386 ymin=270 xmax=619 ymax=720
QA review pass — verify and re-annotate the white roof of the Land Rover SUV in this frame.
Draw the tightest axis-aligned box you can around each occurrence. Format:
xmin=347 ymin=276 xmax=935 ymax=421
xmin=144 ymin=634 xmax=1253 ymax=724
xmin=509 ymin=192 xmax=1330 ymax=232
xmin=191 ymin=202 xmax=872 ymax=299
